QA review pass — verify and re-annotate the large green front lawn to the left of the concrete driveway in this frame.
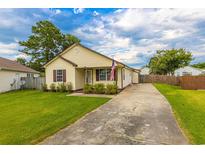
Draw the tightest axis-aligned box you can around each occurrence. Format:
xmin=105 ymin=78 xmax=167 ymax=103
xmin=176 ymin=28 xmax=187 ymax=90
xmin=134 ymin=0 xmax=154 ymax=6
xmin=0 ymin=90 xmax=109 ymax=144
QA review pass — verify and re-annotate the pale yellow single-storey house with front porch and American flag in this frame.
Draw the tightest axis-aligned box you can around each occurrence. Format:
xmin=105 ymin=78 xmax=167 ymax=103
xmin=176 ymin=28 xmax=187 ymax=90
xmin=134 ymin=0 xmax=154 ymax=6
xmin=44 ymin=43 xmax=139 ymax=90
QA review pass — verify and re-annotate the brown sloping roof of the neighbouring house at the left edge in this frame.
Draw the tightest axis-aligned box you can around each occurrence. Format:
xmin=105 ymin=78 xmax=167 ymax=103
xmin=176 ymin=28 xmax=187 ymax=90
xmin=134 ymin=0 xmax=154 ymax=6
xmin=0 ymin=57 xmax=39 ymax=73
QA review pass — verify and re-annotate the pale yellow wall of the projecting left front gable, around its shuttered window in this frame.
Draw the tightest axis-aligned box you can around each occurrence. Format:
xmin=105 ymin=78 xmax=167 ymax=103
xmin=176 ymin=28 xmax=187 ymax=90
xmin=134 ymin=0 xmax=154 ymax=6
xmin=45 ymin=58 xmax=76 ymax=90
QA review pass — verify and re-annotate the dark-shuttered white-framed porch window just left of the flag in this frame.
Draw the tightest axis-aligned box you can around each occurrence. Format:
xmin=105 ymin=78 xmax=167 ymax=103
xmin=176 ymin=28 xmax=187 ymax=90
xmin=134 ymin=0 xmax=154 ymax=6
xmin=96 ymin=69 xmax=111 ymax=81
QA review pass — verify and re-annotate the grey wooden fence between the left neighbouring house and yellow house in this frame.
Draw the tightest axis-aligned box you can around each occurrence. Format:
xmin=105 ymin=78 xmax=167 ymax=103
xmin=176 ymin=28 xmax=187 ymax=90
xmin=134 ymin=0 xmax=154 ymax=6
xmin=23 ymin=77 xmax=45 ymax=90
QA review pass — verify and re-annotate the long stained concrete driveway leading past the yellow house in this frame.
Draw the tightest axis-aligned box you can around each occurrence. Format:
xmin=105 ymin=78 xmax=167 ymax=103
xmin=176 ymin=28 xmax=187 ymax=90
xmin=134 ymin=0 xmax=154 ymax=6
xmin=41 ymin=84 xmax=188 ymax=144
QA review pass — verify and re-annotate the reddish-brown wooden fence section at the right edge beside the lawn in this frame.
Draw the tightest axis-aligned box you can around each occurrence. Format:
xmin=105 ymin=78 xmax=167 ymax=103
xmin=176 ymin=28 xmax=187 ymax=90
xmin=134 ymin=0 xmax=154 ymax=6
xmin=180 ymin=76 xmax=205 ymax=90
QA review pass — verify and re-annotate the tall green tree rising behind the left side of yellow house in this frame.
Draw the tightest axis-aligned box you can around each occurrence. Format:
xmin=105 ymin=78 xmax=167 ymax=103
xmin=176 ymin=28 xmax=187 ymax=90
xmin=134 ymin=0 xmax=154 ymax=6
xmin=19 ymin=20 xmax=80 ymax=71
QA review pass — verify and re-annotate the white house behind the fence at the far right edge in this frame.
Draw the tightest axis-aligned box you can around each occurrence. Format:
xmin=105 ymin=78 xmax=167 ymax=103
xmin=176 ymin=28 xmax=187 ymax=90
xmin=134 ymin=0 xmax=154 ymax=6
xmin=174 ymin=66 xmax=205 ymax=76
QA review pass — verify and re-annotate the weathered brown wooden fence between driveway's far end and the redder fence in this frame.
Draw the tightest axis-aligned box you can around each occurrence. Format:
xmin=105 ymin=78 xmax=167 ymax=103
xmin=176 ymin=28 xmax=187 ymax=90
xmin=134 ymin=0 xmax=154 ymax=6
xmin=140 ymin=75 xmax=179 ymax=85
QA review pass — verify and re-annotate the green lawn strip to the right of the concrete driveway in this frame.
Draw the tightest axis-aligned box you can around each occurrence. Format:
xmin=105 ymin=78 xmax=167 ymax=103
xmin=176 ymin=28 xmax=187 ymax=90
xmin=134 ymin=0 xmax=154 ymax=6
xmin=154 ymin=84 xmax=205 ymax=144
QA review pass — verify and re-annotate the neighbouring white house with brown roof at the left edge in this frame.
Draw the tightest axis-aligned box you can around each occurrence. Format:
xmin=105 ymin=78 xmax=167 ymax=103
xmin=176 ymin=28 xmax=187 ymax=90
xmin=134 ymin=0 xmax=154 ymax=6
xmin=0 ymin=57 xmax=39 ymax=92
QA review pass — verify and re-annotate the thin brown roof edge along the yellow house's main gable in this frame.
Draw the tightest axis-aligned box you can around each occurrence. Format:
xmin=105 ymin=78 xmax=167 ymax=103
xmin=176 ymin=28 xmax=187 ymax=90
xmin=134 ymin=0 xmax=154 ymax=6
xmin=44 ymin=43 xmax=135 ymax=71
